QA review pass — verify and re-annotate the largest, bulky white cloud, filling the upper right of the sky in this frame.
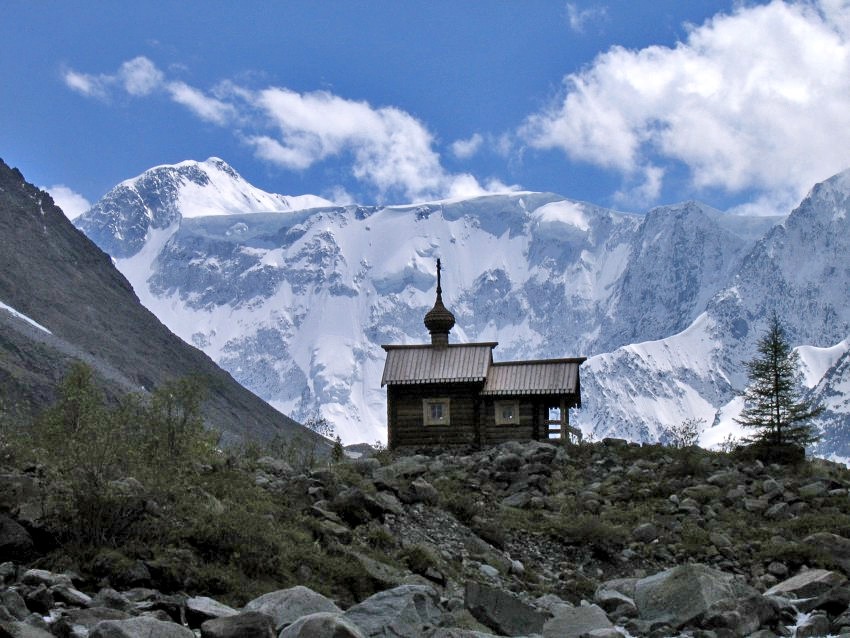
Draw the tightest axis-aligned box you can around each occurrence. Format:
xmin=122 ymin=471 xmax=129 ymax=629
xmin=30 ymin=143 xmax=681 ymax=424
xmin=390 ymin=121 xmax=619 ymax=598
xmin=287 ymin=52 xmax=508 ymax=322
xmin=519 ymin=0 xmax=850 ymax=215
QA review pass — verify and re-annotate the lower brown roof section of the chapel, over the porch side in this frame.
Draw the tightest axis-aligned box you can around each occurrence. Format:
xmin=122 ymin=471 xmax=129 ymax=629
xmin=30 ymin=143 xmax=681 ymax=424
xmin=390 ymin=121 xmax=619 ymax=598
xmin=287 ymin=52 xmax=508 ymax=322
xmin=481 ymin=357 xmax=585 ymax=396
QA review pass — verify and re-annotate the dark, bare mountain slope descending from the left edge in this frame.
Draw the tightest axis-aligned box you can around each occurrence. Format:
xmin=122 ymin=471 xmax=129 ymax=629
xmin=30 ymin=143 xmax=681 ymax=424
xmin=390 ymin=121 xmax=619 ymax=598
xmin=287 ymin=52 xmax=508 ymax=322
xmin=0 ymin=161 xmax=322 ymax=448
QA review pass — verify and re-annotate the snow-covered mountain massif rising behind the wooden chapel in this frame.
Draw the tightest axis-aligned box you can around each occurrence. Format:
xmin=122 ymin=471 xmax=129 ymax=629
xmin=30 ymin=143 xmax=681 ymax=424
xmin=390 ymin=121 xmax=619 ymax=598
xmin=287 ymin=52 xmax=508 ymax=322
xmin=78 ymin=159 xmax=850 ymax=454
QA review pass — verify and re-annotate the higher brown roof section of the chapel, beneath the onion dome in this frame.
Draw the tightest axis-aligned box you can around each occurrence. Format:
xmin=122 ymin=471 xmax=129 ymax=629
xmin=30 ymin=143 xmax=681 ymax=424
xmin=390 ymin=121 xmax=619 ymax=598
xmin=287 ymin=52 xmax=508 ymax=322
xmin=381 ymin=343 xmax=496 ymax=386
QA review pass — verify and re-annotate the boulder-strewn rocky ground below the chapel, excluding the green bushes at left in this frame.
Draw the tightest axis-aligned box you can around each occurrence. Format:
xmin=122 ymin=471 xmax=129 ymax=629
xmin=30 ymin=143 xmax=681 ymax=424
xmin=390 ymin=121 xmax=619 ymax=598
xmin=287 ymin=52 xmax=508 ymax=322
xmin=0 ymin=440 xmax=850 ymax=638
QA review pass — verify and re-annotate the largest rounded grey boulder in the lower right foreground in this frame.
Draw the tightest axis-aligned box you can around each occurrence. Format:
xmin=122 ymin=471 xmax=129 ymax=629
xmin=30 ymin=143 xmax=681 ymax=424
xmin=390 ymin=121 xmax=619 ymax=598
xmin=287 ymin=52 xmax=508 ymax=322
xmin=634 ymin=564 xmax=757 ymax=628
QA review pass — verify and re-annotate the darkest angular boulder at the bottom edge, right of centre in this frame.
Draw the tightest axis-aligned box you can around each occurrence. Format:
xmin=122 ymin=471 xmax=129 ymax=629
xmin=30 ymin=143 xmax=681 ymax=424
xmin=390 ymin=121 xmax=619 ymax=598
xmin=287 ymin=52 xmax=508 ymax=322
xmin=465 ymin=581 xmax=551 ymax=636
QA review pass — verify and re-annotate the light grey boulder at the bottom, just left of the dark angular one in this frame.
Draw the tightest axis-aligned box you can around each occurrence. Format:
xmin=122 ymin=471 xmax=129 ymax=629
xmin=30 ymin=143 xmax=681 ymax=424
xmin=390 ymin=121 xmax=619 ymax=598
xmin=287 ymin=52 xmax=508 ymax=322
xmin=344 ymin=585 xmax=442 ymax=638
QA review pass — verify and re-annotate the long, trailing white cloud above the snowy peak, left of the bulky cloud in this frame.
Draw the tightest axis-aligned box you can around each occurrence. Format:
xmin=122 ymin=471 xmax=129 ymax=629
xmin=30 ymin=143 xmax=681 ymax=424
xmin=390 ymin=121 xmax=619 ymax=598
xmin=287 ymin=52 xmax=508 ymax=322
xmin=64 ymin=57 xmax=511 ymax=200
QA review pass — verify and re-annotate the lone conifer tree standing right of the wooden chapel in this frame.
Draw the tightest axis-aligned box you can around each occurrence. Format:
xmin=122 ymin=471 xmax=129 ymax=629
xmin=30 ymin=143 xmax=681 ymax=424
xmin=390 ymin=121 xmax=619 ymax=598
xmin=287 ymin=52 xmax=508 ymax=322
xmin=736 ymin=315 xmax=823 ymax=447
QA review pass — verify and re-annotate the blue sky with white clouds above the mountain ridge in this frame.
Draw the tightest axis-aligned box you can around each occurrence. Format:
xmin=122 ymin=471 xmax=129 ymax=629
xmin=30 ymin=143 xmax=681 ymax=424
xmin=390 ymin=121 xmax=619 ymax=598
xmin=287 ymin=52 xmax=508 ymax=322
xmin=0 ymin=0 xmax=850 ymax=219
